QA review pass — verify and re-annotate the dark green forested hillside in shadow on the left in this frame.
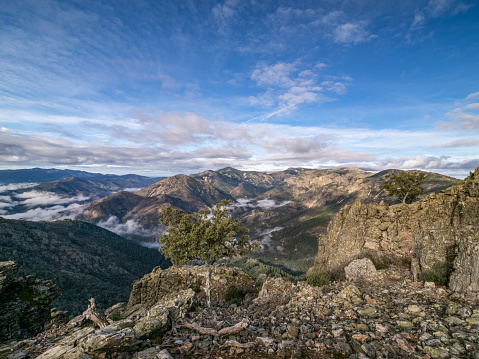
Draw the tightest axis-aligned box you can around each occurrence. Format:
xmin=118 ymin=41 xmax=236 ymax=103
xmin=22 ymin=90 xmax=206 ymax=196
xmin=0 ymin=217 xmax=169 ymax=314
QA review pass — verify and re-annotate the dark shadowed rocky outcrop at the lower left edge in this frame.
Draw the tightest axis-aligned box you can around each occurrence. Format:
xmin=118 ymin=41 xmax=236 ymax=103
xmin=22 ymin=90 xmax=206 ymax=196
xmin=0 ymin=261 xmax=61 ymax=343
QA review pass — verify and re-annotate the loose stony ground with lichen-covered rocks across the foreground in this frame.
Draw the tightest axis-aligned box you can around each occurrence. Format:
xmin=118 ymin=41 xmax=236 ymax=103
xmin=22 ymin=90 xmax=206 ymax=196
xmin=0 ymin=264 xmax=479 ymax=359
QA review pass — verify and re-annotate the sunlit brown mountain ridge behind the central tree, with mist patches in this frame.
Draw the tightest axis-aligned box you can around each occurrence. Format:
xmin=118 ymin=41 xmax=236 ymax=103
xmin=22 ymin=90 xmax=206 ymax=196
xmin=78 ymin=167 xmax=461 ymax=270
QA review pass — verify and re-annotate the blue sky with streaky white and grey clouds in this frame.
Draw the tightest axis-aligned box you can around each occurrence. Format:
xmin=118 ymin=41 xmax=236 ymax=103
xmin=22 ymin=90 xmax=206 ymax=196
xmin=0 ymin=0 xmax=479 ymax=178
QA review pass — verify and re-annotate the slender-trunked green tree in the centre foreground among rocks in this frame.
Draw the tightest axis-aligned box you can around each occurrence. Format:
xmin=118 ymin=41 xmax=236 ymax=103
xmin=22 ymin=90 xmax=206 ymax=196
xmin=160 ymin=200 xmax=259 ymax=307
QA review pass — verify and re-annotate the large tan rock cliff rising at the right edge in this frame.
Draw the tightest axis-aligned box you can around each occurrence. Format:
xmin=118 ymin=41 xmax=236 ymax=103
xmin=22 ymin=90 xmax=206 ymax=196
xmin=315 ymin=168 xmax=479 ymax=291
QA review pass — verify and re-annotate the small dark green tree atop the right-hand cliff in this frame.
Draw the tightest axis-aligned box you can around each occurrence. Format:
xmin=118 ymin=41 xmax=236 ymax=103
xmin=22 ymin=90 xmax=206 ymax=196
xmin=383 ymin=171 xmax=426 ymax=203
